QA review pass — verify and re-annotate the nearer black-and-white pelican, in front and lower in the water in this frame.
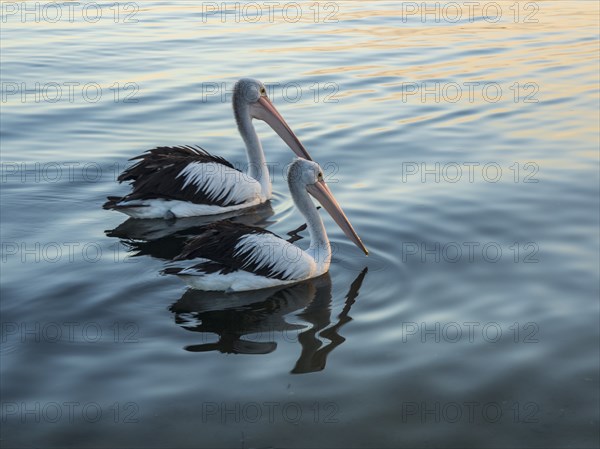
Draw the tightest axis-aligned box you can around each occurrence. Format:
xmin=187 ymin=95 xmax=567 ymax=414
xmin=163 ymin=159 xmax=368 ymax=292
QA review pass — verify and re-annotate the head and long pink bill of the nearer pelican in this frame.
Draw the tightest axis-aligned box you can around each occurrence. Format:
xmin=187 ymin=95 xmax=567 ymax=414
xmin=288 ymin=159 xmax=369 ymax=255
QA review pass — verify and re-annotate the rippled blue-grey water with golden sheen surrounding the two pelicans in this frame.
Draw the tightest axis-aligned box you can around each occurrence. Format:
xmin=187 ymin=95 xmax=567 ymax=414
xmin=0 ymin=1 xmax=600 ymax=448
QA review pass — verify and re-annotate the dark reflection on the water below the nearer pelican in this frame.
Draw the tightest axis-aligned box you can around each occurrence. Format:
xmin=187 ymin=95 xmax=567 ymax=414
xmin=169 ymin=267 xmax=367 ymax=374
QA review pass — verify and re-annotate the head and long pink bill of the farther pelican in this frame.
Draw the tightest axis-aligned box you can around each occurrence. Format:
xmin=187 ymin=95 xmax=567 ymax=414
xmin=233 ymin=78 xmax=312 ymax=160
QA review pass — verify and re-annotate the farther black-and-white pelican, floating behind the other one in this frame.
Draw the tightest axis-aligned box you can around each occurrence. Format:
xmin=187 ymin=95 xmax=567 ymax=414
xmin=103 ymin=78 xmax=312 ymax=219
